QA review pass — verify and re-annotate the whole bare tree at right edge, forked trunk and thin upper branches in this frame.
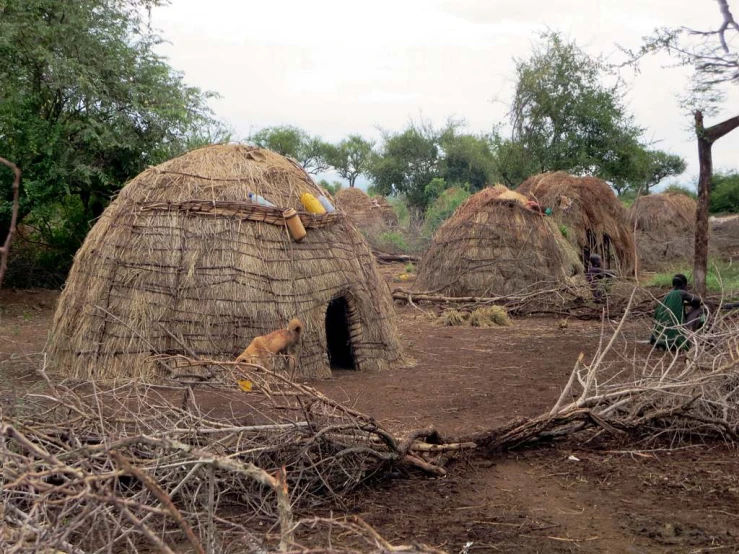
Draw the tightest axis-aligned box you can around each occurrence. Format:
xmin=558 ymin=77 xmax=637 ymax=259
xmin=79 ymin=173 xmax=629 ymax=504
xmin=629 ymin=0 xmax=739 ymax=295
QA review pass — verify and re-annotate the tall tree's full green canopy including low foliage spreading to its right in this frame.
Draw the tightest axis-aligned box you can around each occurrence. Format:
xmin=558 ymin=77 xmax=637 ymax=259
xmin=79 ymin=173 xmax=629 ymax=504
xmin=502 ymin=32 xmax=685 ymax=192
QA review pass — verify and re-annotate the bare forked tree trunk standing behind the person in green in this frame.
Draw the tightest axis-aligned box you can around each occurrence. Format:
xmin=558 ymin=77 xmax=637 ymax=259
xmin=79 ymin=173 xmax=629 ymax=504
xmin=693 ymin=110 xmax=739 ymax=296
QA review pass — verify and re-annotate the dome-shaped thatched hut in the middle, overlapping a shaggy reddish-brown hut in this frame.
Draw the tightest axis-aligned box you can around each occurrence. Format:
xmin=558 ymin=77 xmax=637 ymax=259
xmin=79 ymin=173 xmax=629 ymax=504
xmin=416 ymin=185 xmax=583 ymax=296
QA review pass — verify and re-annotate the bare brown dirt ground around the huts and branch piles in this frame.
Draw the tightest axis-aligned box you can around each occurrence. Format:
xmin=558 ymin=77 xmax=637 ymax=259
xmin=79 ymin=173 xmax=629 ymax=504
xmin=0 ymin=278 xmax=739 ymax=554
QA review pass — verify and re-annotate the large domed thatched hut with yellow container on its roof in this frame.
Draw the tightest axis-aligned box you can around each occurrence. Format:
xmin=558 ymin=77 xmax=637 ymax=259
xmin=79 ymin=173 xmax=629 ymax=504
xmin=49 ymin=145 xmax=401 ymax=378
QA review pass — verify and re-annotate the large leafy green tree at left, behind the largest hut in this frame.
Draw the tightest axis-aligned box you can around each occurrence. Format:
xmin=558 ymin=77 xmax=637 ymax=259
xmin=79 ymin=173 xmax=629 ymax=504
xmin=0 ymin=0 xmax=223 ymax=276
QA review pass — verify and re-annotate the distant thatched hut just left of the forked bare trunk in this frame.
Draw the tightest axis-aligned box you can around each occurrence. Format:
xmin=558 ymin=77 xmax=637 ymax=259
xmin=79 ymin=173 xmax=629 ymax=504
xmin=629 ymin=193 xmax=697 ymax=271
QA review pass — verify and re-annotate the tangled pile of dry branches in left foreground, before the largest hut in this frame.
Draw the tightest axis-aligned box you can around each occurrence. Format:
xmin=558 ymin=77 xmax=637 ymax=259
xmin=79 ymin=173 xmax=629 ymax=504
xmin=0 ymin=359 xmax=444 ymax=554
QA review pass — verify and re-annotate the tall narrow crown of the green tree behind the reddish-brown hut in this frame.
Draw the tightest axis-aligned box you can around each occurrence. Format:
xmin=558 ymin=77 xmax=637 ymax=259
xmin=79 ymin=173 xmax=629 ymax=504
xmin=510 ymin=32 xmax=642 ymax=180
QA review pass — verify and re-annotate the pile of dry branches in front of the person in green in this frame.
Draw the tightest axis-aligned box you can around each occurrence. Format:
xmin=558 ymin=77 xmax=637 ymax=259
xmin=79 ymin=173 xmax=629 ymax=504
xmin=460 ymin=291 xmax=739 ymax=450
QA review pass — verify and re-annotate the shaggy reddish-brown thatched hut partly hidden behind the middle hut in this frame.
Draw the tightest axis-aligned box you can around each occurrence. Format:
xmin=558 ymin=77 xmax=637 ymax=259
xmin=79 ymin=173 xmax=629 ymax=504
xmin=516 ymin=171 xmax=636 ymax=276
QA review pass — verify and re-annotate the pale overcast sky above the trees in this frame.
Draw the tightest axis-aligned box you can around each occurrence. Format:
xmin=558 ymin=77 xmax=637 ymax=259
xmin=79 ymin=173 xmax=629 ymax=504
xmin=153 ymin=0 xmax=739 ymax=189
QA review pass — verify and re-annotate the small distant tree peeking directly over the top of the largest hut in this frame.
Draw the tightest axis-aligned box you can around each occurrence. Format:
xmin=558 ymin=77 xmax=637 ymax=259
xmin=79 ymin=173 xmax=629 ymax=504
xmin=249 ymin=125 xmax=331 ymax=175
